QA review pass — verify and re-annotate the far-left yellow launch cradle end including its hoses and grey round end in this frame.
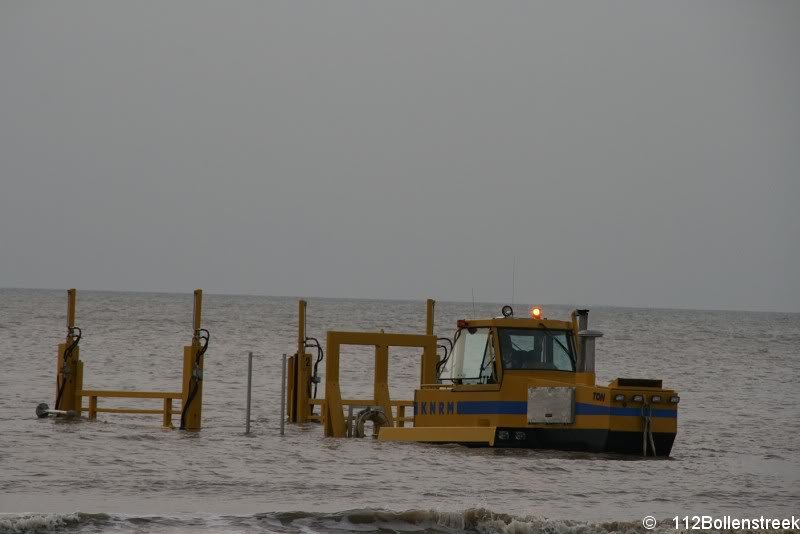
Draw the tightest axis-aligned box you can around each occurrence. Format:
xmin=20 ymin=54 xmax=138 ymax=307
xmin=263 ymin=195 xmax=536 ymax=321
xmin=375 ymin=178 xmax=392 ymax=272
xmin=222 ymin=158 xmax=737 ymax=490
xmin=36 ymin=289 xmax=209 ymax=431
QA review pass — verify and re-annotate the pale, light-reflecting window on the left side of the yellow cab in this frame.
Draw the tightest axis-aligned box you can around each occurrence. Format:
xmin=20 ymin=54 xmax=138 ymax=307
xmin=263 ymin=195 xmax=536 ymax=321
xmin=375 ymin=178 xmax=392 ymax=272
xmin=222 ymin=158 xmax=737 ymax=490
xmin=440 ymin=328 xmax=497 ymax=384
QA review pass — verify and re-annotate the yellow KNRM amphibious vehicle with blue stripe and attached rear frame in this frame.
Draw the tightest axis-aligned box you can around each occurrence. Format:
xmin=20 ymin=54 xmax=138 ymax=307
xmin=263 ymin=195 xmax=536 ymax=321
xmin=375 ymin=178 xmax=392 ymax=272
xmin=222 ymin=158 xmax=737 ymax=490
xmin=287 ymin=301 xmax=680 ymax=456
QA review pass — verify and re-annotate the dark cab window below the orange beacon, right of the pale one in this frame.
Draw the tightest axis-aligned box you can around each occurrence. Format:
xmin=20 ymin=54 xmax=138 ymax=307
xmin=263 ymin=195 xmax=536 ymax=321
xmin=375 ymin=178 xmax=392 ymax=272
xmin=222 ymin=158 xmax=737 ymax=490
xmin=498 ymin=328 xmax=575 ymax=372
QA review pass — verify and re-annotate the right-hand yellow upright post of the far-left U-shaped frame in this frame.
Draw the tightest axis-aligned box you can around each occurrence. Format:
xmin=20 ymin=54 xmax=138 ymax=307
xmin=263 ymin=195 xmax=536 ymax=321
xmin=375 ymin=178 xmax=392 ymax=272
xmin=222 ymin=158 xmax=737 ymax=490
xmin=181 ymin=289 xmax=203 ymax=431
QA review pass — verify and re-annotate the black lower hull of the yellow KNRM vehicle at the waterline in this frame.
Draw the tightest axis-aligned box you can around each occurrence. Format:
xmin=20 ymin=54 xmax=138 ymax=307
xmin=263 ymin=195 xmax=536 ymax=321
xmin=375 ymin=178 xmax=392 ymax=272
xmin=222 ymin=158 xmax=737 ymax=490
xmin=494 ymin=428 xmax=675 ymax=456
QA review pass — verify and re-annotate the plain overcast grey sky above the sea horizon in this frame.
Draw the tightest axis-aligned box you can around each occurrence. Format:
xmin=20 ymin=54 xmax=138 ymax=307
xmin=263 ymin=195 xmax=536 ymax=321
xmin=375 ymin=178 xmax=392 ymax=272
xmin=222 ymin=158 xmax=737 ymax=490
xmin=0 ymin=0 xmax=800 ymax=311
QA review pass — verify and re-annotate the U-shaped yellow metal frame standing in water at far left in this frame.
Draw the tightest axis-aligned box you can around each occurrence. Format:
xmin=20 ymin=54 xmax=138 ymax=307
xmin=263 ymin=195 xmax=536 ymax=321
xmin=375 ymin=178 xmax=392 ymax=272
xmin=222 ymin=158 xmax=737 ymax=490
xmin=51 ymin=289 xmax=203 ymax=431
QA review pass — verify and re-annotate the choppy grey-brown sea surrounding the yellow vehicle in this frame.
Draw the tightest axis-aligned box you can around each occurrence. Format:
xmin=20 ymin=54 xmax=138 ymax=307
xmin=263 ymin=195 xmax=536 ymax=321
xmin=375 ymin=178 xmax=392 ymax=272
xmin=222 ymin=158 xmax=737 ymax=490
xmin=0 ymin=289 xmax=800 ymax=534
